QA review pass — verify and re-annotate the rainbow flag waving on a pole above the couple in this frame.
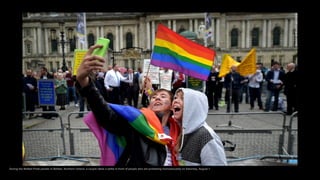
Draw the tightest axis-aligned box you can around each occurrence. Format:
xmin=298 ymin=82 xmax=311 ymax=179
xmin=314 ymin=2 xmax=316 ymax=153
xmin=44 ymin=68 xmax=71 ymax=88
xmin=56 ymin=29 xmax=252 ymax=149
xmin=150 ymin=24 xmax=215 ymax=80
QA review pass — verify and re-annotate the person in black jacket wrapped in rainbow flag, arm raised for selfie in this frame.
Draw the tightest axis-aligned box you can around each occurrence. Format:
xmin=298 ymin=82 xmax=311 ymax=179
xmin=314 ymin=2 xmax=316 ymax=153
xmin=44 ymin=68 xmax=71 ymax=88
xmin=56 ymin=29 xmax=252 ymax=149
xmin=76 ymin=45 xmax=180 ymax=167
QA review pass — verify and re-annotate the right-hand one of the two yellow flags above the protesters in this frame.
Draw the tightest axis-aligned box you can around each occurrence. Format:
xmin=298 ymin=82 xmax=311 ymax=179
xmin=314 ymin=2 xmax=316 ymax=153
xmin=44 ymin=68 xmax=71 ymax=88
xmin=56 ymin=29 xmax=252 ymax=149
xmin=237 ymin=48 xmax=257 ymax=76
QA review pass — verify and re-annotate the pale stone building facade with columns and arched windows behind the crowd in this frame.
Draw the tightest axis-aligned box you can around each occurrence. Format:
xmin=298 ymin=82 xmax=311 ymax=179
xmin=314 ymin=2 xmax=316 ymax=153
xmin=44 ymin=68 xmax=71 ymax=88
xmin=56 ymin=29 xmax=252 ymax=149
xmin=22 ymin=12 xmax=298 ymax=72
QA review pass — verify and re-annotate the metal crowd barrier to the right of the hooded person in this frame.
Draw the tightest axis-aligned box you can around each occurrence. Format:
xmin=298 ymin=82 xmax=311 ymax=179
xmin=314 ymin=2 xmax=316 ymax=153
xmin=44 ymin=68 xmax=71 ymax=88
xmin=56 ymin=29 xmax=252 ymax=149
xmin=207 ymin=111 xmax=297 ymax=165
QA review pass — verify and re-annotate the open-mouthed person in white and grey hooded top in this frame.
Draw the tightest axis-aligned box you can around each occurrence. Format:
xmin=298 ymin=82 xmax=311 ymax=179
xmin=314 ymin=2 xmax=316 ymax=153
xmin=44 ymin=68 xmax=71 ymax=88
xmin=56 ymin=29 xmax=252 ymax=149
xmin=172 ymin=88 xmax=227 ymax=166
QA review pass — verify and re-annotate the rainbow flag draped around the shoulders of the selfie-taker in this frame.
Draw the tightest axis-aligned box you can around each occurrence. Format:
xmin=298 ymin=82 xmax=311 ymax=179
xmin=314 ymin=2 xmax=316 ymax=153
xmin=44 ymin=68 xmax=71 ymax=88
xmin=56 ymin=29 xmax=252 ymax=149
xmin=84 ymin=103 xmax=172 ymax=166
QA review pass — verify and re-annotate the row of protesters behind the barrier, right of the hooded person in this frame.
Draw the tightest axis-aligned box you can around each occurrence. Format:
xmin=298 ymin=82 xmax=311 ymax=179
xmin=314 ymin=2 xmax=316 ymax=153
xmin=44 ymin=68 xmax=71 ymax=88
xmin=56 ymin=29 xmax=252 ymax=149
xmin=205 ymin=61 xmax=298 ymax=115
